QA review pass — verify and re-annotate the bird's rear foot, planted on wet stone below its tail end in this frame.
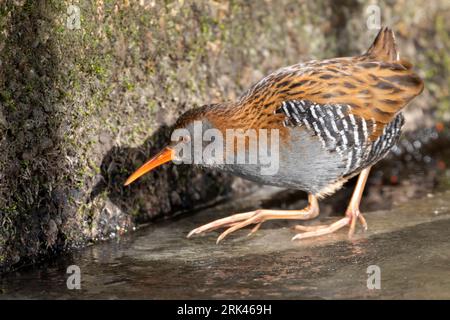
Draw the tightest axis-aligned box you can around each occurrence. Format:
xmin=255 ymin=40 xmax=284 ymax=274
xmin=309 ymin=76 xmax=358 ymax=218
xmin=292 ymin=208 xmax=367 ymax=240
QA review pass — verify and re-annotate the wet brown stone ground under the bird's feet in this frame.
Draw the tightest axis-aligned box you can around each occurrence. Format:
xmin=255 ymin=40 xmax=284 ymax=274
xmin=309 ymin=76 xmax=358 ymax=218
xmin=0 ymin=189 xmax=450 ymax=299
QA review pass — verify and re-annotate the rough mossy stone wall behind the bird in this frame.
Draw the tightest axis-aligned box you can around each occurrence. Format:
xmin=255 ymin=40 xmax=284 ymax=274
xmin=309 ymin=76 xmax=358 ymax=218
xmin=0 ymin=0 xmax=450 ymax=270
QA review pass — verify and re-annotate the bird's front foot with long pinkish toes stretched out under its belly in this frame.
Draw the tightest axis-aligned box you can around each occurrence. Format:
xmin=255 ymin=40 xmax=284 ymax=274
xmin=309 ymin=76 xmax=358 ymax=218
xmin=187 ymin=196 xmax=319 ymax=243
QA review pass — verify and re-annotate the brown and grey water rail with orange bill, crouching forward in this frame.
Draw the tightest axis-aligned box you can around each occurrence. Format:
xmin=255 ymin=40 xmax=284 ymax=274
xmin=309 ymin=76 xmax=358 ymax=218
xmin=125 ymin=27 xmax=424 ymax=242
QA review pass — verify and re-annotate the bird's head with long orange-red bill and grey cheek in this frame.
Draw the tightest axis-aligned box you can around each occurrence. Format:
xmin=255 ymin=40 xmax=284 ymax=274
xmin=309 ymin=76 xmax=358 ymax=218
xmin=125 ymin=105 xmax=215 ymax=186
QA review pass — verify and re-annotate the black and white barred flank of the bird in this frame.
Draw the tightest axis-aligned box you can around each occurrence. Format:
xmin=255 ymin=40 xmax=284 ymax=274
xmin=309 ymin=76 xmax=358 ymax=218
xmin=276 ymin=100 xmax=404 ymax=176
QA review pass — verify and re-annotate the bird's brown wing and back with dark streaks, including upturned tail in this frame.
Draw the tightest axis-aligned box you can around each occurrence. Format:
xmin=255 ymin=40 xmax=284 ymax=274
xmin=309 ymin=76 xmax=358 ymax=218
xmin=239 ymin=28 xmax=423 ymax=141
